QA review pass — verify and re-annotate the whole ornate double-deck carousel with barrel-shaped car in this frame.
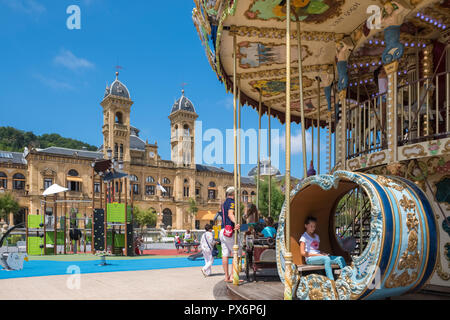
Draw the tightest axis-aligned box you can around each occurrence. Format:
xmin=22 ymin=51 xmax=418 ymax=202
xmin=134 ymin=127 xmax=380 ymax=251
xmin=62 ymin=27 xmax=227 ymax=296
xmin=192 ymin=0 xmax=450 ymax=300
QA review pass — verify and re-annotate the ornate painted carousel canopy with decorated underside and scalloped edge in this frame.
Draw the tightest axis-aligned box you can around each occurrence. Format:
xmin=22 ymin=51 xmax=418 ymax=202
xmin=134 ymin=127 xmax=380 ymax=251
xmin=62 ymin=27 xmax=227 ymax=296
xmin=192 ymin=0 xmax=450 ymax=127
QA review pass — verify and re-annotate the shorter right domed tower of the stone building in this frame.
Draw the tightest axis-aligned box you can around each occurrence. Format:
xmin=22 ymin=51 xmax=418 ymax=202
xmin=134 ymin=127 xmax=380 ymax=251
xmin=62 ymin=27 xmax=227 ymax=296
xmin=169 ymin=90 xmax=198 ymax=169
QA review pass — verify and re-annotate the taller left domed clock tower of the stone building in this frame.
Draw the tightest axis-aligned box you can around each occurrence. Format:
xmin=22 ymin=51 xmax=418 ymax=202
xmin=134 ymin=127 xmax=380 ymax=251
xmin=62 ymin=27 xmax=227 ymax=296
xmin=100 ymin=72 xmax=133 ymax=162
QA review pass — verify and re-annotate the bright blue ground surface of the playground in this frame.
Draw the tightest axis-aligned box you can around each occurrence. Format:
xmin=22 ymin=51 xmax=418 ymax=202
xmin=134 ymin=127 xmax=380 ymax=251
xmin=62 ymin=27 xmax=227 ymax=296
xmin=0 ymin=258 xmax=222 ymax=279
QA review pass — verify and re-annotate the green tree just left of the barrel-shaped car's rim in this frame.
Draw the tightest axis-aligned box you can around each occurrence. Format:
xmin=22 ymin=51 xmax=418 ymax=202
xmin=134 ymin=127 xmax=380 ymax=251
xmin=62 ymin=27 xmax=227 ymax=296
xmin=259 ymin=176 xmax=284 ymax=221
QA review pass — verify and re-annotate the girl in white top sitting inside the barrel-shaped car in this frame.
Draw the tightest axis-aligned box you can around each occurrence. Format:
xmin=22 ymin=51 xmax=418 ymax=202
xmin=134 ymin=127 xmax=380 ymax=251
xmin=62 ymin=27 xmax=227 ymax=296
xmin=300 ymin=217 xmax=346 ymax=280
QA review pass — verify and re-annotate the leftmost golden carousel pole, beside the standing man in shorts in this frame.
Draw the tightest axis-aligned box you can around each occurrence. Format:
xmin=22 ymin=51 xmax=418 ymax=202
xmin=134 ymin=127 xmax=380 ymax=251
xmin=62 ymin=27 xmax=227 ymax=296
xmin=232 ymin=35 xmax=239 ymax=286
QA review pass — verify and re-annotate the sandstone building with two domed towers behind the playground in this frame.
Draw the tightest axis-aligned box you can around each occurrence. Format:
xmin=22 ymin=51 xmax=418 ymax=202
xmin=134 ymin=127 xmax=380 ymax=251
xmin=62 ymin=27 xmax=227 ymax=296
xmin=0 ymin=73 xmax=256 ymax=229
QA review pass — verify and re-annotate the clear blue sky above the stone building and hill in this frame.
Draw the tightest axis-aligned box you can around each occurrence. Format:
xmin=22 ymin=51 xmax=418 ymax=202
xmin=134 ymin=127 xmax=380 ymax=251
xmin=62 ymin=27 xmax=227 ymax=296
xmin=0 ymin=0 xmax=325 ymax=177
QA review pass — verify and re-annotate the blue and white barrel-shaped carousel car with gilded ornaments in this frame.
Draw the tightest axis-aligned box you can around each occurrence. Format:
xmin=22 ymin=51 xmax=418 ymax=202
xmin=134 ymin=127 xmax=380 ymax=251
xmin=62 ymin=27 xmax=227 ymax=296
xmin=277 ymin=171 xmax=438 ymax=300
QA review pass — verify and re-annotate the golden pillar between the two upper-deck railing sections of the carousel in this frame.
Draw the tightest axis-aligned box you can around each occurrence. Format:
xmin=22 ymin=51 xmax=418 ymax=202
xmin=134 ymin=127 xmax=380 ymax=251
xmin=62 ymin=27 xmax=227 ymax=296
xmin=384 ymin=61 xmax=398 ymax=162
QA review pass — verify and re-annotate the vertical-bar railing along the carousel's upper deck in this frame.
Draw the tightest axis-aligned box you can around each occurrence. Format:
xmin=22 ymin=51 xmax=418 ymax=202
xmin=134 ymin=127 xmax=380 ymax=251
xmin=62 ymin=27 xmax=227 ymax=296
xmin=346 ymin=71 xmax=450 ymax=159
